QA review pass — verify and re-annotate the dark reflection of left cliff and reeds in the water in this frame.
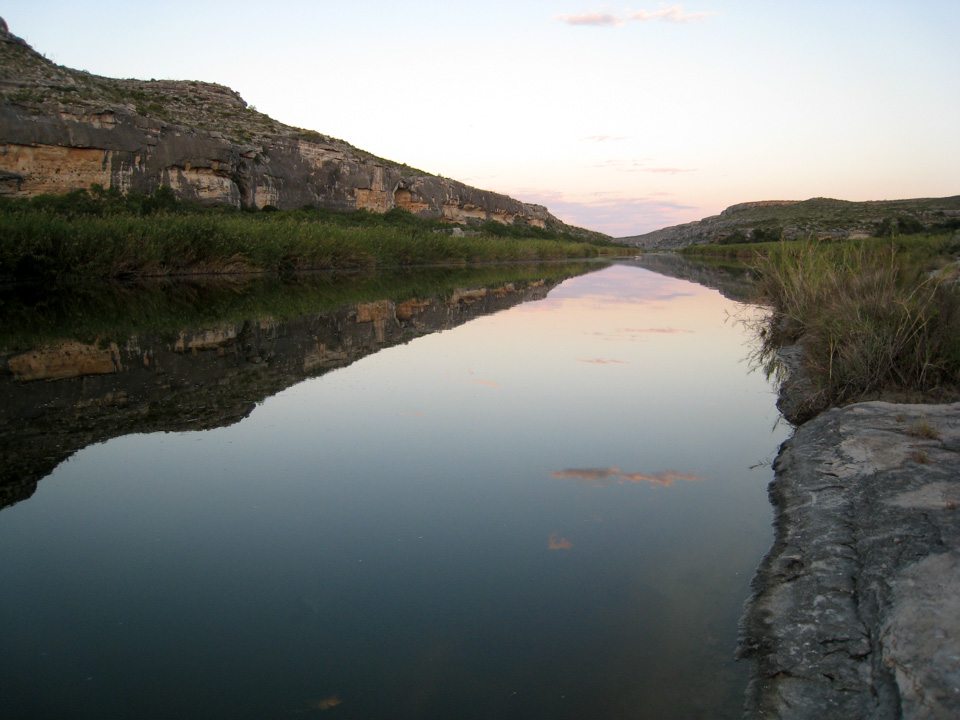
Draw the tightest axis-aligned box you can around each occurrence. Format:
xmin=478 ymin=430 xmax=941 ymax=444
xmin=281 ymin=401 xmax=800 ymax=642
xmin=0 ymin=263 xmax=599 ymax=508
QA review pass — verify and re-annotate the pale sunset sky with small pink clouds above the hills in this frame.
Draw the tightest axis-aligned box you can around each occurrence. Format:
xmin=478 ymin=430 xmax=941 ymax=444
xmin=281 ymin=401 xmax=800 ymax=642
xmin=0 ymin=0 xmax=960 ymax=237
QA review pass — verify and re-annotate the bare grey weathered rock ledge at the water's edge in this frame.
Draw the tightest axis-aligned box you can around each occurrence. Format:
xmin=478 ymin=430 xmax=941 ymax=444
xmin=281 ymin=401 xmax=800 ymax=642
xmin=739 ymin=402 xmax=960 ymax=720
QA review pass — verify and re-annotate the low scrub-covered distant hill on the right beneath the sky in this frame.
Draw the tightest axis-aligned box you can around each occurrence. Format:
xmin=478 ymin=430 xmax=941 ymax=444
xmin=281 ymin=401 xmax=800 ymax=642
xmin=617 ymin=195 xmax=960 ymax=250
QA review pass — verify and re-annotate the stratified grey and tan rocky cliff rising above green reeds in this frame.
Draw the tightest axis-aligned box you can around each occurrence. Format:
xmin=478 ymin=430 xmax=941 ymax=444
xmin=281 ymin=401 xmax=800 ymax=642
xmin=0 ymin=20 xmax=585 ymax=232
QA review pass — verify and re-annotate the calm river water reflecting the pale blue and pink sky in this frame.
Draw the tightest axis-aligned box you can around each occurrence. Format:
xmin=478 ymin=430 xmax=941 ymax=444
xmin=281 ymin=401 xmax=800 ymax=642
xmin=0 ymin=265 xmax=786 ymax=720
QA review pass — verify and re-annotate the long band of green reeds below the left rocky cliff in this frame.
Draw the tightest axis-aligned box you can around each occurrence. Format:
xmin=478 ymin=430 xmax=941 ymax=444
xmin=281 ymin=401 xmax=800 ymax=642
xmin=0 ymin=188 xmax=616 ymax=280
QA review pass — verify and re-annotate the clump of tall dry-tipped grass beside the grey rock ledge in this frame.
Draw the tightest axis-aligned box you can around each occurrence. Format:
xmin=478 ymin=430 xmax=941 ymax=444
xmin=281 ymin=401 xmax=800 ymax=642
xmin=755 ymin=242 xmax=960 ymax=412
